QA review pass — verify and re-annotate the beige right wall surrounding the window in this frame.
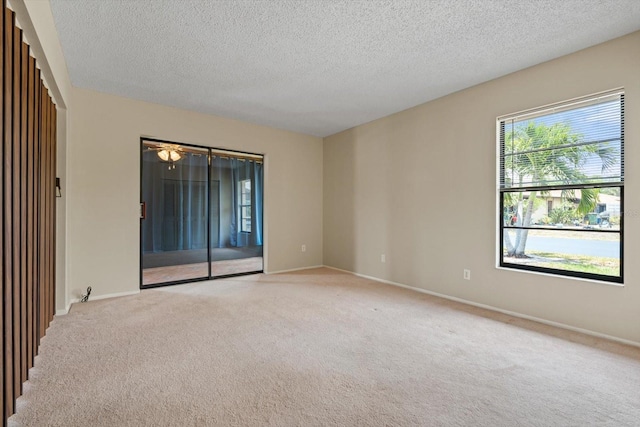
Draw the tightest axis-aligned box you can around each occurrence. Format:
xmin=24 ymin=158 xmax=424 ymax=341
xmin=324 ymin=32 xmax=640 ymax=343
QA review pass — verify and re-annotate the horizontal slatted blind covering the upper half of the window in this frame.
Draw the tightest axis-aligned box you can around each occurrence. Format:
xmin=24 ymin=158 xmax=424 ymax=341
xmin=499 ymin=91 xmax=624 ymax=191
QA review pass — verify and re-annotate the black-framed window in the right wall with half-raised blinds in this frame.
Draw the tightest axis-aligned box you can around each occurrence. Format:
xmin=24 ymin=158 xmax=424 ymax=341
xmin=497 ymin=91 xmax=624 ymax=283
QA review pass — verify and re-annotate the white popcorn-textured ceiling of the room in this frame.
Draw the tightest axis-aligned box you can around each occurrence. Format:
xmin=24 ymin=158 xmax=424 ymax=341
xmin=50 ymin=0 xmax=640 ymax=136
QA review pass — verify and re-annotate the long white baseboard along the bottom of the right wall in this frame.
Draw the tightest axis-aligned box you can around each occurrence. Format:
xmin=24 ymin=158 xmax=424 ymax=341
xmin=324 ymin=265 xmax=640 ymax=348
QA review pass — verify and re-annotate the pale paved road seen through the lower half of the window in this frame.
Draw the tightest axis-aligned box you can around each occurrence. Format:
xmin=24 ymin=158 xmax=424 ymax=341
xmin=526 ymin=236 xmax=620 ymax=258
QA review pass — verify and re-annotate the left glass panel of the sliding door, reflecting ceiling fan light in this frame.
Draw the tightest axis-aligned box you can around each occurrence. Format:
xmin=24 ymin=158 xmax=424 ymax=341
xmin=141 ymin=141 xmax=209 ymax=286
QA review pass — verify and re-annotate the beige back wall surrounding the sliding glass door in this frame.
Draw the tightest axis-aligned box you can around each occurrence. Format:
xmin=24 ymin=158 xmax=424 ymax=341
xmin=67 ymin=88 xmax=322 ymax=299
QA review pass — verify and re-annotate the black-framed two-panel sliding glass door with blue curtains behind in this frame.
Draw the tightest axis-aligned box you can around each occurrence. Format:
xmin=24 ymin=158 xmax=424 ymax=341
xmin=140 ymin=139 xmax=263 ymax=287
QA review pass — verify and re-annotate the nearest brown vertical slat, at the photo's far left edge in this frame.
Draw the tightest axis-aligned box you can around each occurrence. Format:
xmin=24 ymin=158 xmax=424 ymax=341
xmin=2 ymin=8 xmax=15 ymax=419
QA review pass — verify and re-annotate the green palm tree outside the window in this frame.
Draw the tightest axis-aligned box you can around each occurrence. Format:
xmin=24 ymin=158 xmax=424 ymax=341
xmin=503 ymin=122 xmax=617 ymax=258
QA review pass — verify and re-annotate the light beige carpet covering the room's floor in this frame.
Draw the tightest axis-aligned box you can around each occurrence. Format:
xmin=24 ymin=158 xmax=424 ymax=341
xmin=10 ymin=269 xmax=640 ymax=426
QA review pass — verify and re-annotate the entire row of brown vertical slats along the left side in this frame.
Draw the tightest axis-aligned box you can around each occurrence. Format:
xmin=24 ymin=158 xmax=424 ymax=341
xmin=0 ymin=0 xmax=57 ymax=426
